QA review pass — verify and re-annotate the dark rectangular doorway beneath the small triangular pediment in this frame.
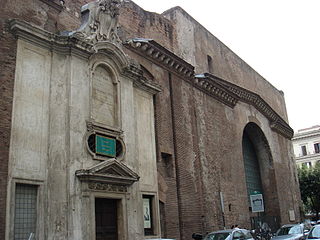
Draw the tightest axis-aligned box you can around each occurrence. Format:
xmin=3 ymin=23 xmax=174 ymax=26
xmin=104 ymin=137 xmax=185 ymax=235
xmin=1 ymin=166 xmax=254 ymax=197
xmin=95 ymin=198 xmax=119 ymax=240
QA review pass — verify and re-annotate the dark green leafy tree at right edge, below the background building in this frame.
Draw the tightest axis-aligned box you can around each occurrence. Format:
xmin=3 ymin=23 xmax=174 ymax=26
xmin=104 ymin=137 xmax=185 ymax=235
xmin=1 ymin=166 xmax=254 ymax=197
xmin=298 ymin=162 xmax=320 ymax=219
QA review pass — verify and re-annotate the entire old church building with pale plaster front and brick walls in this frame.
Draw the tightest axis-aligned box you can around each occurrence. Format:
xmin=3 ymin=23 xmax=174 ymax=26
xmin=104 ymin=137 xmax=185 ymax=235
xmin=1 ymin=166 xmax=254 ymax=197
xmin=0 ymin=0 xmax=300 ymax=240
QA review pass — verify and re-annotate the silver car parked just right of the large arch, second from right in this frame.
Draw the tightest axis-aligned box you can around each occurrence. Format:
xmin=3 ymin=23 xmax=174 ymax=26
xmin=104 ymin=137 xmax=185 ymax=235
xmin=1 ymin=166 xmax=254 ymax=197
xmin=272 ymin=223 xmax=309 ymax=240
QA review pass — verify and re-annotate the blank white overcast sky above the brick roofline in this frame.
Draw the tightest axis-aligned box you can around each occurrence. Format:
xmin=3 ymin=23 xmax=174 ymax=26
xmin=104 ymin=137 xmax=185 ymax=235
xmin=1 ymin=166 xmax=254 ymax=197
xmin=129 ymin=0 xmax=320 ymax=131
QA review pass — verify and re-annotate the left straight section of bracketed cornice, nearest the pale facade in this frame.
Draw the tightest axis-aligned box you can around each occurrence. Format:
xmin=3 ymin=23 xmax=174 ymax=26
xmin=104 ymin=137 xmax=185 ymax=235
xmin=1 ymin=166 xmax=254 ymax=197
xmin=124 ymin=38 xmax=194 ymax=79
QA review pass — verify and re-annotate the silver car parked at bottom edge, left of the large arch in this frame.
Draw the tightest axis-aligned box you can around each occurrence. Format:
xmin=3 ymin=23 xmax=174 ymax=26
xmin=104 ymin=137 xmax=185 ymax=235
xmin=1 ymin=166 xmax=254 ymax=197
xmin=192 ymin=228 xmax=254 ymax=240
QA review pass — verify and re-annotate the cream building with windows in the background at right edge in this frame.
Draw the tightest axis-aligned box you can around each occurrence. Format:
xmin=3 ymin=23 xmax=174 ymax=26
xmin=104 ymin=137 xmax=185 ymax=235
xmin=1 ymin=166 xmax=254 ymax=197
xmin=292 ymin=125 xmax=320 ymax=168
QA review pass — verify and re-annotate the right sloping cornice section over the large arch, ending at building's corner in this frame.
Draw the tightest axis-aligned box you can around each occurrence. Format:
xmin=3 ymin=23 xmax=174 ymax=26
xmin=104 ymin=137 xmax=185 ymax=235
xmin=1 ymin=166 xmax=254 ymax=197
xmin=200 ymin=73 xmax=293 ymax=139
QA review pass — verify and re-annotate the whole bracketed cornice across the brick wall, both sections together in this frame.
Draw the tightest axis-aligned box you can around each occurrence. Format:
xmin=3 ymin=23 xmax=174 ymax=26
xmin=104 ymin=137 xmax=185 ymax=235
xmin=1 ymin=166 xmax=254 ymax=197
xmin=124 ymin=38 xmax=293 ymax=139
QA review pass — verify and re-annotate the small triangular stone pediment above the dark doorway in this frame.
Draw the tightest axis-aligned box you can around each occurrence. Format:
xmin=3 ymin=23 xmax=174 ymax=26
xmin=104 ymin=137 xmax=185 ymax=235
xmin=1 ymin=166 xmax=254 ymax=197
xmin=76 ymin=159 xmax=139 ymax=186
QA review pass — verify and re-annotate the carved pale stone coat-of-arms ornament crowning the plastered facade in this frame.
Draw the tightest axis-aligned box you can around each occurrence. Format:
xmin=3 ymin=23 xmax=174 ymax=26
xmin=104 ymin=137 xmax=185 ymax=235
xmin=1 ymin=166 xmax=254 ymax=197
xmin=72 ymin=0 xmax=121 ymax=45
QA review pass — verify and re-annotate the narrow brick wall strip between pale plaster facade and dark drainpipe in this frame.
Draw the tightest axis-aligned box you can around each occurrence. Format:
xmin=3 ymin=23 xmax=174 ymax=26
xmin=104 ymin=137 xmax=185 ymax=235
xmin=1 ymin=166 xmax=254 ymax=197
xmin=155 ymin=71 xmax=180 ymax=240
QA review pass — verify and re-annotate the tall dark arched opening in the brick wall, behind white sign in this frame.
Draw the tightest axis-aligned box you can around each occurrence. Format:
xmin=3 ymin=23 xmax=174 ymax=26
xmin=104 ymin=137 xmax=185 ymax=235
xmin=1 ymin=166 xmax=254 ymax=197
xmin=242 ymin=122 xmax=280 ymax=228
